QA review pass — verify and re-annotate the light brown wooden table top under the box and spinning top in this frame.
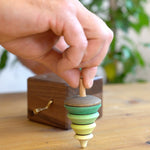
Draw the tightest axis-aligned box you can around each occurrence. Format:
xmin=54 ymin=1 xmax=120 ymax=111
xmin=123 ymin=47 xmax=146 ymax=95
xmin=0 ymin=83 xmax=150 ymax=150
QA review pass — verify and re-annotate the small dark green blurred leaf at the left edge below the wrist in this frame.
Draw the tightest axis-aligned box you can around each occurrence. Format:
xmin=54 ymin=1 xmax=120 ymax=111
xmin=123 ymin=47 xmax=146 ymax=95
xmin=0 ymin=50 xmax=8 ymax=71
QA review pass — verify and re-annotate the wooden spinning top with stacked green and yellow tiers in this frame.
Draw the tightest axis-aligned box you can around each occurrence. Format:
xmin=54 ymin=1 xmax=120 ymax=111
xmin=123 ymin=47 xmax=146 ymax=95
xmin=64 ymin=79 xmax=101 ymax=148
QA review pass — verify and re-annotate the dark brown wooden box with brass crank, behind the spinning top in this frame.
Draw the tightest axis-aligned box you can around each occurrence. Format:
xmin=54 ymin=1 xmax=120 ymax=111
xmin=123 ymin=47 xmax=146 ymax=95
xmin=27 ymin=73 xmax=103 ymax=129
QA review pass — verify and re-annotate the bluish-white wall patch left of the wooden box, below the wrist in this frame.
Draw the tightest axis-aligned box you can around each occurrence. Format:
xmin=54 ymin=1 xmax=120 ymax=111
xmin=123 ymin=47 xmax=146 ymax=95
xmin=0 ymin=49 xmax=34 ymax=93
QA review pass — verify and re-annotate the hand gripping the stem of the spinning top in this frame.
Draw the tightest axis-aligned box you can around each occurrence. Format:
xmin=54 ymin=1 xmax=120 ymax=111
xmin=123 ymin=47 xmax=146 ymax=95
xmin=0 ymin=0 xmax=113 ymax=88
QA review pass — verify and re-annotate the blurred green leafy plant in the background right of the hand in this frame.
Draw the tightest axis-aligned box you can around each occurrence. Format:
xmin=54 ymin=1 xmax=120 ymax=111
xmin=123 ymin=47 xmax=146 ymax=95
xmin=80 ymin=0 xmax=150 ymax=83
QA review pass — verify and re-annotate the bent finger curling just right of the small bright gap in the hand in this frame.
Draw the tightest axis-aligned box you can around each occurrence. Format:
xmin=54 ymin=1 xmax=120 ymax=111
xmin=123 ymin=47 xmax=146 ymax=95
xmin=57 ymin=16 xmax=87 ymax=72
